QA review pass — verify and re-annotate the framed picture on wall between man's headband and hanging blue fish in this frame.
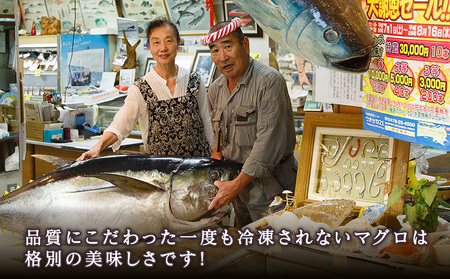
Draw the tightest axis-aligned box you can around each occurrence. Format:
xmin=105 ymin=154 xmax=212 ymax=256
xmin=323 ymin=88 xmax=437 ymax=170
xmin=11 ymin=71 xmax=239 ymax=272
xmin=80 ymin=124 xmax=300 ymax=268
xmin=222 ymin=0 xmax=263 ymax=38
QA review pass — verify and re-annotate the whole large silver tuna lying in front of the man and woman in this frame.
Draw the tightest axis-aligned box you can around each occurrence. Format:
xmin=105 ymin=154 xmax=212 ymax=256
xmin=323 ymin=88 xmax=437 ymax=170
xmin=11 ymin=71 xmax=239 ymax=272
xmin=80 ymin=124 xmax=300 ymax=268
xmin=0 ymin=155 xmax=242 ymax=234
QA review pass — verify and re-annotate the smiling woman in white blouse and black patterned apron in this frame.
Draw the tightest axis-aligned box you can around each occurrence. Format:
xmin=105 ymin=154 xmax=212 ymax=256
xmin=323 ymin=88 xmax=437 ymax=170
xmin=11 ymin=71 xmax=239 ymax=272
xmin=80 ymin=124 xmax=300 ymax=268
xmin=77 ymin=19 xmax=213 ymax=160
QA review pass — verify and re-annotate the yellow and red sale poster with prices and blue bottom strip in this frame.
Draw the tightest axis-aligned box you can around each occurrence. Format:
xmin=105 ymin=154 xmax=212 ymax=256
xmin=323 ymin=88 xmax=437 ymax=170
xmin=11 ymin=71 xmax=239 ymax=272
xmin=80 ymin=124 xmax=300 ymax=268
xmin=362 ymin=0 xmax=450 ymax=150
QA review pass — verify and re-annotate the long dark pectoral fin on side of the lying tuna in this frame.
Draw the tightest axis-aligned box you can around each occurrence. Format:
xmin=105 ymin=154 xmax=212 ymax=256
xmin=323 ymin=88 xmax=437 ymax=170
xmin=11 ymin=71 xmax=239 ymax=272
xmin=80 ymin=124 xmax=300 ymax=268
xmin=89 ymin=173 xmax=165 ymax=196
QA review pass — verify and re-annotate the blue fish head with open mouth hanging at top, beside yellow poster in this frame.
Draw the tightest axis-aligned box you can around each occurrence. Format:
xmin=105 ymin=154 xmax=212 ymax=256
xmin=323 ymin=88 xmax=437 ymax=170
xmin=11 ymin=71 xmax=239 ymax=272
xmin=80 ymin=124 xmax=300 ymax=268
xmin=233 ymin=0 xmax=375 ymax=72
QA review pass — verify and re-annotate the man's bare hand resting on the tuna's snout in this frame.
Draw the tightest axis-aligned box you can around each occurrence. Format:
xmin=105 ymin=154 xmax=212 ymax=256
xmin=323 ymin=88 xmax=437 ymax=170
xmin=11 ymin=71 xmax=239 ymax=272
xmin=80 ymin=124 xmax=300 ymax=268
xmin=208 ymin=172 xmax=255 ymax=210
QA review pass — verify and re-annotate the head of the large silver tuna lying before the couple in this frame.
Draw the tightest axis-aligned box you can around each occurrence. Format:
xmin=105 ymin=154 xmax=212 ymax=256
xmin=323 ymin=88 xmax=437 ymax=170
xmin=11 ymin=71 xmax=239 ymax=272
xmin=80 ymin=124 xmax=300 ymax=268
xmin=170 ymin=159 xmax=242 ymax=221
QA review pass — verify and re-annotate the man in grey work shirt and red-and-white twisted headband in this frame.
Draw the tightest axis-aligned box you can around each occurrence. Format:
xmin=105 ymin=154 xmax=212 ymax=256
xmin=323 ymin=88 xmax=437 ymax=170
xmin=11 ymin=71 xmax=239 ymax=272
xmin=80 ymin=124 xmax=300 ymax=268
xmin=202 ymin=21 xmax=297 ymax=230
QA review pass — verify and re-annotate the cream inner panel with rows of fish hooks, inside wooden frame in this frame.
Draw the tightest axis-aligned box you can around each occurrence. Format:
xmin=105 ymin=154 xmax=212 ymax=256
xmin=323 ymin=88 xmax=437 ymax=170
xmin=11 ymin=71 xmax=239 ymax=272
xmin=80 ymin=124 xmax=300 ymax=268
xmin=308 ymin=127 xmax=394 ymax=205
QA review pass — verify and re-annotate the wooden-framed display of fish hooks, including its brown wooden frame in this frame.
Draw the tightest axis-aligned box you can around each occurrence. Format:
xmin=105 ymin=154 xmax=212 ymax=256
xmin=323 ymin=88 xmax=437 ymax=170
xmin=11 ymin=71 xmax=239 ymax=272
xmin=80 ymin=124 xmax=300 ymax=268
xmin=294 ymin=112 xmax=410 ymax=227
